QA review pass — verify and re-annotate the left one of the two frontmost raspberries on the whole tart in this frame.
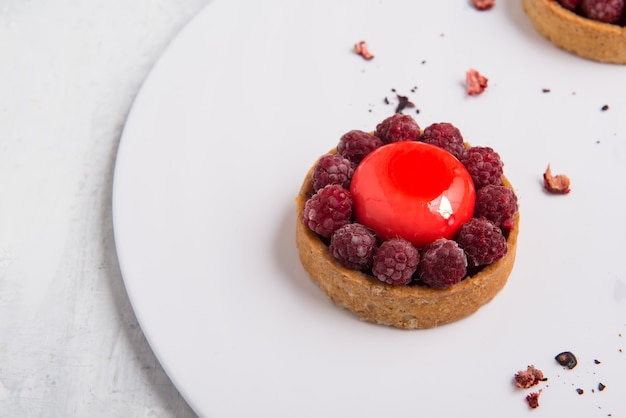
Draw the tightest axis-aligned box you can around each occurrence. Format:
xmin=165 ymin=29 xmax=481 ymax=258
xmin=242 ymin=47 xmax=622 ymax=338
xmin=372 ymin=238 xmax=420 ymax=285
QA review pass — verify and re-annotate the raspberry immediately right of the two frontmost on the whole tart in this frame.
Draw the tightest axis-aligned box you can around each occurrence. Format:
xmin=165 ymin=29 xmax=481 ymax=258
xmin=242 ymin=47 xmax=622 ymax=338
xmin=456 ymin=218 xmax=508 ymax=267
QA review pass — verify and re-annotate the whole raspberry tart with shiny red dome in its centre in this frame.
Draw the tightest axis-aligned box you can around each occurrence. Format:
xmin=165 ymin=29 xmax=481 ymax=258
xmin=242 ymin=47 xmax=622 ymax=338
xmin=296 ymin=114 xmax=519 ymax=329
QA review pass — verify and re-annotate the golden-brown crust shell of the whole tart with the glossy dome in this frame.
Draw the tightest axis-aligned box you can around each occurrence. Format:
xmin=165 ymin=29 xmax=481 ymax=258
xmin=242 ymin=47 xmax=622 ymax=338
xmin=296 ymin=153 xmax=519 ymax=329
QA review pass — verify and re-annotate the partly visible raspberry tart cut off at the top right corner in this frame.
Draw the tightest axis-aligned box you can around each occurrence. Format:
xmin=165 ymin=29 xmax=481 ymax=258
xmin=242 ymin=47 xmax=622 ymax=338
xmin=522 ymin=0 xmax=626 ymax=64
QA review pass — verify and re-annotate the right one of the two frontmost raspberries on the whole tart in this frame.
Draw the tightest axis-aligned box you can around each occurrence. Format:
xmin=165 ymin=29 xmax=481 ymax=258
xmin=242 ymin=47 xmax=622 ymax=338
xmin=417 ymin=238 xmax=467 ymax=289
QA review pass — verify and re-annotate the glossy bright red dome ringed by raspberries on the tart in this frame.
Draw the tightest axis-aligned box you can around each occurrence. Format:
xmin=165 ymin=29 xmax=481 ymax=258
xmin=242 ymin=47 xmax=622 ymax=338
xmin=350 ymin=141 xmax=476 ymax=248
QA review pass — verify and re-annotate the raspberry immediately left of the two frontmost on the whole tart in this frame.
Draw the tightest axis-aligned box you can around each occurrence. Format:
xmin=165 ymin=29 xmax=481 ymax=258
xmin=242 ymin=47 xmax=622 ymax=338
xmin=328 ymin=223 xmax=376 ymax=270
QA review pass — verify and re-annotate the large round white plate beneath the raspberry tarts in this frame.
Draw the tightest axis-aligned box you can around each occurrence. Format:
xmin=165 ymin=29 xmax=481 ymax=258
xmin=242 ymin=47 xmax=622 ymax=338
xmin=113 ymin=0 xmax=626 ymax=417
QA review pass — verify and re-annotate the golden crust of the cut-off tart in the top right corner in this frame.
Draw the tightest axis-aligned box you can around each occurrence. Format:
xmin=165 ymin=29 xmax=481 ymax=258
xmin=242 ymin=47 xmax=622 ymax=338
xmin=522 ymin=0 xmax=626 ymax=64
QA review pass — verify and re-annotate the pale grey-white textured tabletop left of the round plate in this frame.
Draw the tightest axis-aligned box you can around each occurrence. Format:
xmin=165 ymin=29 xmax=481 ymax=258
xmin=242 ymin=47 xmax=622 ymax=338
xmin=0 ymin=0 xmax=207 ymax=417
